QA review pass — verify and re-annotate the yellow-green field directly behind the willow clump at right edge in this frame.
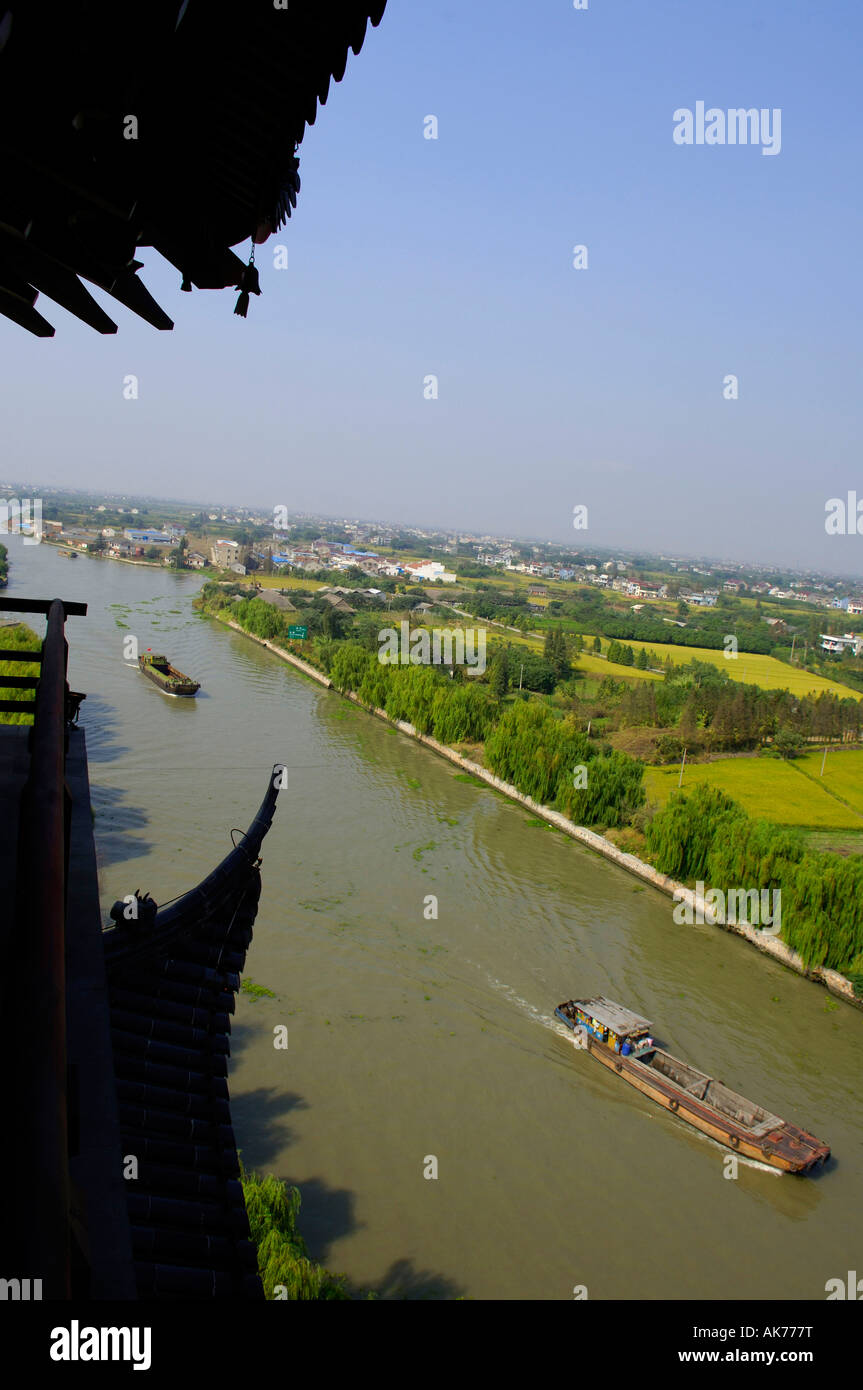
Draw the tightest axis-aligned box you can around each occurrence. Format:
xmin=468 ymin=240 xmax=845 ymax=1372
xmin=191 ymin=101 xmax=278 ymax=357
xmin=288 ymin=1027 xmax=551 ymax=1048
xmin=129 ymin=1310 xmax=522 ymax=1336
xmin=645 ymin=753 xmax=863 ymax=830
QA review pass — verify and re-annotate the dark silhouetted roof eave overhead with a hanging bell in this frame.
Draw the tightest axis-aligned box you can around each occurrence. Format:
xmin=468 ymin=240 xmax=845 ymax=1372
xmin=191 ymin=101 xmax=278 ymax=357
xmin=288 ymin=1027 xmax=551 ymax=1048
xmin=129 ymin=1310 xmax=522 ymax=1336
xmin=0 ymin=0 xmax=386 ymax=336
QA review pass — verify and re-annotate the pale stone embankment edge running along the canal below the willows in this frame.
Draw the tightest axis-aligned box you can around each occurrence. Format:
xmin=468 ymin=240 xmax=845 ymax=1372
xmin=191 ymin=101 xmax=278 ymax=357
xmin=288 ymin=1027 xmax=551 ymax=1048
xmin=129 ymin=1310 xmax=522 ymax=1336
xmin=213 ymin=614 xmax=863 ymax=1009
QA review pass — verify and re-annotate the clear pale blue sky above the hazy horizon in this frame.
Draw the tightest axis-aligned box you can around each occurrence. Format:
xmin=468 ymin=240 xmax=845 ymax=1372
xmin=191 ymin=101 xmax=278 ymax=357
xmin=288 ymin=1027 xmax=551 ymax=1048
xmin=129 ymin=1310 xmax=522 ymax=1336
xmin=0 ymin=0 xmax=863 ymax=573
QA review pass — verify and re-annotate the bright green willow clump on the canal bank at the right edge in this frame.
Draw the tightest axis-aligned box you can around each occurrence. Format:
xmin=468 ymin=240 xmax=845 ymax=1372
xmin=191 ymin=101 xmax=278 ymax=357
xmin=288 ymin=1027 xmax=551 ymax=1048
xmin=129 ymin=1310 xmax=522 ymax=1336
xmin=646 ymin=785 xmax=863 ymax=992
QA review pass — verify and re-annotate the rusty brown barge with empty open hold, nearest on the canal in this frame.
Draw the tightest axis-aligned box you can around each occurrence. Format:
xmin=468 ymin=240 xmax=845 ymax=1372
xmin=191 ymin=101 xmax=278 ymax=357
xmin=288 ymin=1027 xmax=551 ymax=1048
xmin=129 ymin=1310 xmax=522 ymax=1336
xmin=554 ymin=994 xmax=830 ymax=1173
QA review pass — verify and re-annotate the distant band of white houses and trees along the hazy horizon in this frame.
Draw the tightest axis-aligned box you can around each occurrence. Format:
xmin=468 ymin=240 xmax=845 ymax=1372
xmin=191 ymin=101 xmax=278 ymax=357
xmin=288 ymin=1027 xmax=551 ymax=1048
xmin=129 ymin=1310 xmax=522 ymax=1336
xmin=8 ymin=489 xmax=863 ymax=656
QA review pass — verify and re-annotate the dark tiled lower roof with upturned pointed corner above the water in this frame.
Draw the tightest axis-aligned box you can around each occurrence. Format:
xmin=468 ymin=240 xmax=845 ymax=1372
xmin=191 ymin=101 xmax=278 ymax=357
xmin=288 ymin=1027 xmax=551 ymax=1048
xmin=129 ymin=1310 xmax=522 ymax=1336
xmin=103 ymin=769 xmax=278 ymax=1298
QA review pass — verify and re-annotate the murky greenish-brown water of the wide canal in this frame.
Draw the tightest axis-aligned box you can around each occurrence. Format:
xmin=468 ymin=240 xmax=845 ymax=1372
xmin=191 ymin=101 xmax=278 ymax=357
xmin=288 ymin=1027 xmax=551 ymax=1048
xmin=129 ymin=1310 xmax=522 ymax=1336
xmin=8 ymin=541 xmax=863 ymax=1300
